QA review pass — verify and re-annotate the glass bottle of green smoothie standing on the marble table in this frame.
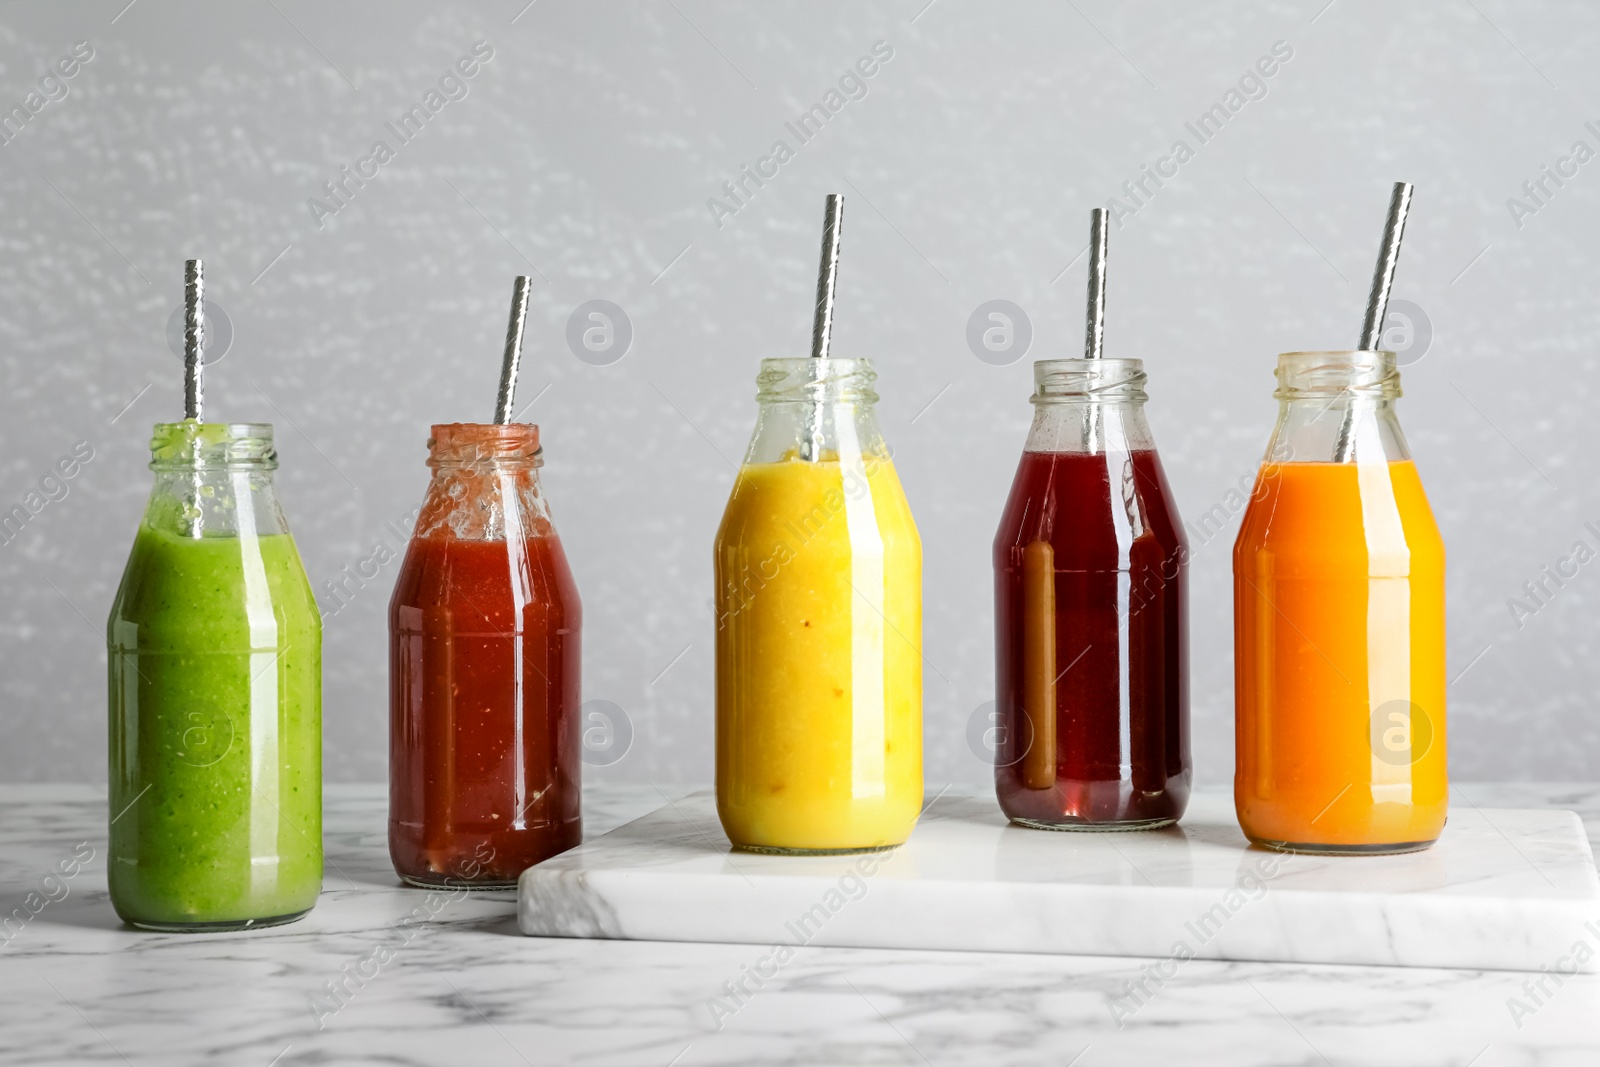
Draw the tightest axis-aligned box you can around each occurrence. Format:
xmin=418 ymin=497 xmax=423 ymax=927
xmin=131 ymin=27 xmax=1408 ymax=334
xmin=106 ymin=421 xmax=322 ymax=931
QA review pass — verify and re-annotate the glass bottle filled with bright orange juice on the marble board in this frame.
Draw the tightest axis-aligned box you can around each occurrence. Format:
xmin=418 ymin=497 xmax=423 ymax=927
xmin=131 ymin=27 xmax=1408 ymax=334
xmin=1234 ymin=352 xmax=1448 ymax=854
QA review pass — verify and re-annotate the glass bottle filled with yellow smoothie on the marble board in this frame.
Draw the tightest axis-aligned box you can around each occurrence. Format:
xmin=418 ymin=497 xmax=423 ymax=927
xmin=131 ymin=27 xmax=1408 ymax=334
xmin=715 ymin=358 xmax=922 ymax=853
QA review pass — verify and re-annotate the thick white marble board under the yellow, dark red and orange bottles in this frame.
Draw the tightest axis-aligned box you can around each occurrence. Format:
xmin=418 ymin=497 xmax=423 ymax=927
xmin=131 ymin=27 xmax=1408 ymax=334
xmin=517 ymin=793 xmax=1600 ymax=973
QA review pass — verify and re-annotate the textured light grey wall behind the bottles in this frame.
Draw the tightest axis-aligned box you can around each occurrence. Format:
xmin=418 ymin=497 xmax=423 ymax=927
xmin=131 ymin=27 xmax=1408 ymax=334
xmin=0 ymin=0 xmax=1600 ymax=782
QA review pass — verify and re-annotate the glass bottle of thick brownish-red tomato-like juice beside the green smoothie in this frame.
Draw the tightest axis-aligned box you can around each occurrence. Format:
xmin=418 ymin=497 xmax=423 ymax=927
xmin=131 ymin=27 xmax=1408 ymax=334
xmin=389 ymin=422 xmax=582 ymax=889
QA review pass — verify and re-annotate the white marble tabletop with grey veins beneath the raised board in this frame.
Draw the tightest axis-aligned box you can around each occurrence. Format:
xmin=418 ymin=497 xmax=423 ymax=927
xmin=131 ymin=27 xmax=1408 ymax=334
xmin=0 ymin=784 xmax=1600 ymax=1067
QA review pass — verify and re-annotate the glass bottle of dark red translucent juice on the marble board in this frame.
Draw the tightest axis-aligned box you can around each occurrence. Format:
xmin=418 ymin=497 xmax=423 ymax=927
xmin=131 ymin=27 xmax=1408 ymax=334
xmin=994 ymin=358 xmax=1192 ymax=830
